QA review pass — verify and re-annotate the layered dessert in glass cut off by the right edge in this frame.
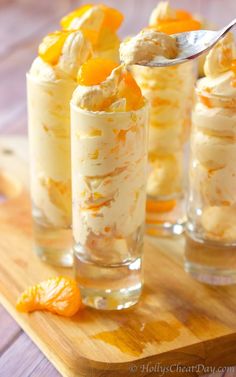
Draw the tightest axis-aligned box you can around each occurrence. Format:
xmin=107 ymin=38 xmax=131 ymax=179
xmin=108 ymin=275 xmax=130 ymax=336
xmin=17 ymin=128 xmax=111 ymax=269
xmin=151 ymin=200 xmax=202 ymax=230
xmin=185 ymin=34 xmax=236 ymax=285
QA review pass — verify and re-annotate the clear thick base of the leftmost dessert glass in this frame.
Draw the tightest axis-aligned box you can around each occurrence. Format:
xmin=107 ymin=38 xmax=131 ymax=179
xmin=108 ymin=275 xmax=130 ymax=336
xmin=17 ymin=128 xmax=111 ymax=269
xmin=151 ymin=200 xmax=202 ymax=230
xmin=34 ymin=223 xmax=73 ymax=267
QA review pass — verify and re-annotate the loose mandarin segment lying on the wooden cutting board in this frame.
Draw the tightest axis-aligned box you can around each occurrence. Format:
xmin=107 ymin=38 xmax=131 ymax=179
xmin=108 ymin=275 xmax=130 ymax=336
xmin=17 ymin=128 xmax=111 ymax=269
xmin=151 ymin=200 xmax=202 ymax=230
xmin=16 ymin=276 xmax=82 ymax=317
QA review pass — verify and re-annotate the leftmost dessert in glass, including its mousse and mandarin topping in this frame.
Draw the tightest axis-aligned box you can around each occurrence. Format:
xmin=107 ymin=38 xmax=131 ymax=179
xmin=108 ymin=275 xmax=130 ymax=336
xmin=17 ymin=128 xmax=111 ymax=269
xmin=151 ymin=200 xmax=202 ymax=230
xmin=27 ymin=5 xmax=122 ymax=266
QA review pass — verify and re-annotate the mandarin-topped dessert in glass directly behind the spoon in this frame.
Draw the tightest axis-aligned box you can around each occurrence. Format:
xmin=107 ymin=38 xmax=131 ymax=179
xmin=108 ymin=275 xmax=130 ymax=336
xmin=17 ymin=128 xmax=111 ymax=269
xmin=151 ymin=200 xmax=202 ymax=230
xmin=132 ymin=2 xmax=200 ymax=236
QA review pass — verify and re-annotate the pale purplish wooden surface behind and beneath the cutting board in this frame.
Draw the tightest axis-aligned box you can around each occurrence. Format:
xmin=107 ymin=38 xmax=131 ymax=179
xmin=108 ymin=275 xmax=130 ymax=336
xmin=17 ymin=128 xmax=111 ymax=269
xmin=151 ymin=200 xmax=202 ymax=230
xmin=0 ymin=0 xmax=236 ymax=377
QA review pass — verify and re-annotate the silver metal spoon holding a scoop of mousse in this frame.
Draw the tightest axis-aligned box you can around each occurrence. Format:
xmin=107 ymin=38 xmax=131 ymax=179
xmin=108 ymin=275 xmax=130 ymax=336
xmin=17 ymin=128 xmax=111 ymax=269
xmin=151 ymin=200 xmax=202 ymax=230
xmin=136 ymin=18 xmax=236 ymax=67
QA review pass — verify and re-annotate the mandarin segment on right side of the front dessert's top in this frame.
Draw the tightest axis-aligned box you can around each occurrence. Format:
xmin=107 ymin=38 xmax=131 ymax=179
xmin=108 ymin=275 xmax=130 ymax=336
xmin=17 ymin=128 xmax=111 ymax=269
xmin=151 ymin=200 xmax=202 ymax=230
xmin=119 ymin=72 xmax=143 ymax=111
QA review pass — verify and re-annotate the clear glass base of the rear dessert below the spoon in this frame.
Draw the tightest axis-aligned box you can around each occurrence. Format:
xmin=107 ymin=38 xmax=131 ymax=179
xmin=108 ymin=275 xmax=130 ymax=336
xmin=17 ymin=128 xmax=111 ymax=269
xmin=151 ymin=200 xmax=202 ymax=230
xmin=146 ymin=197 xmax=186 ymax=237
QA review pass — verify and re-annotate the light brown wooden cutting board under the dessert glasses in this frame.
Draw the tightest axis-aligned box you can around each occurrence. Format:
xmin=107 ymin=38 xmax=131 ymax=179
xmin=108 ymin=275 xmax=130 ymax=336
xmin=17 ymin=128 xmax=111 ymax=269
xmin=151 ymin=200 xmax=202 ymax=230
xmin=0 ymin=138 xmax=236 ymax=377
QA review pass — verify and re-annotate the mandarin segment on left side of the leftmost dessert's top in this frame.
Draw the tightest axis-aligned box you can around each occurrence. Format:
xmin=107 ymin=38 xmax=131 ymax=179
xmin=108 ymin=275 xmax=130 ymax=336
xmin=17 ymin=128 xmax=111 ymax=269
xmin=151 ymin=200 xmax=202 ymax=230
xmin=38 ymin=30 xmax=70 ymax=65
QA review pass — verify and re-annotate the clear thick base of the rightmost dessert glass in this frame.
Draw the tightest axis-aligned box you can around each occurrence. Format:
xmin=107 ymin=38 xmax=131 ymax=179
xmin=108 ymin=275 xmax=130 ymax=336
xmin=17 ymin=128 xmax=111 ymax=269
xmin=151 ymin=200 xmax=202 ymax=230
xmin=184 ymin=233 xmax=236 ymax=285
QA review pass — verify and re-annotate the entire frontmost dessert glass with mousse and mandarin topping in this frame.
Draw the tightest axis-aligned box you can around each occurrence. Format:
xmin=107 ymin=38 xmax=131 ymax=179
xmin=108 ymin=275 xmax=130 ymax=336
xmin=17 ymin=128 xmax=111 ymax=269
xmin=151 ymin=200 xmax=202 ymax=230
xmin=71 ymin=58 xmax=148 ymax=310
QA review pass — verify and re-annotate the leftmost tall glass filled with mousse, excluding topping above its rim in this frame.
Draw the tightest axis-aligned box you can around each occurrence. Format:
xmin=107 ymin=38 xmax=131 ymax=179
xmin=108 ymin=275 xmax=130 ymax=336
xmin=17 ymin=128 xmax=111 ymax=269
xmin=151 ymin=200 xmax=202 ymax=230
xmin=27 ymin=73 xmax=76 ymax=266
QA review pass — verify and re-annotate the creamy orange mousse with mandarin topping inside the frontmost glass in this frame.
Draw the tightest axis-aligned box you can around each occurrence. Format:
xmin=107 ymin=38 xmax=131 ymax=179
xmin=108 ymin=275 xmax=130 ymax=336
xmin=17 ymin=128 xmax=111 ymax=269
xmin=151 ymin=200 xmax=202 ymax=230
xmin=71 ymin=55 xmax=147 ymax=244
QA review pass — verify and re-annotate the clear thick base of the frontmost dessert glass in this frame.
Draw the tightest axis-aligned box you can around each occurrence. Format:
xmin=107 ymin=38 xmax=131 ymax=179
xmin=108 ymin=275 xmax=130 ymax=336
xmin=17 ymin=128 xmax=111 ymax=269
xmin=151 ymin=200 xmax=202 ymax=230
xmin=74 ymin=246 xmax=142 ymax=310
